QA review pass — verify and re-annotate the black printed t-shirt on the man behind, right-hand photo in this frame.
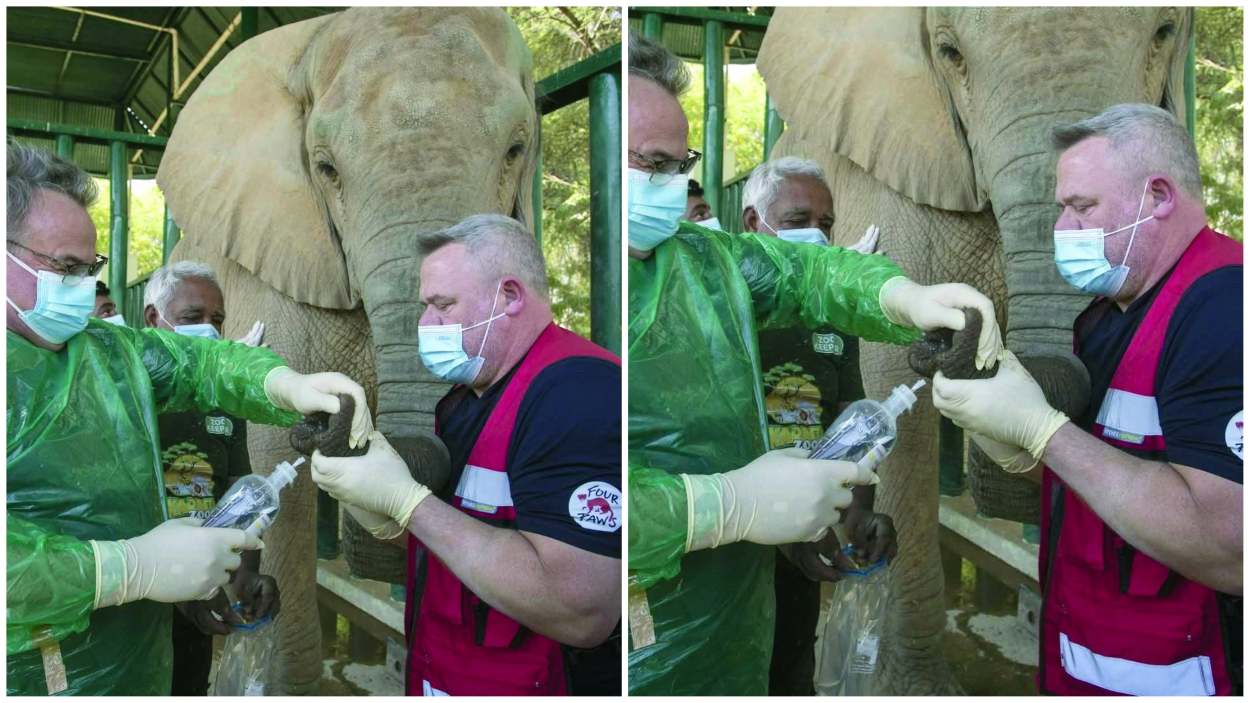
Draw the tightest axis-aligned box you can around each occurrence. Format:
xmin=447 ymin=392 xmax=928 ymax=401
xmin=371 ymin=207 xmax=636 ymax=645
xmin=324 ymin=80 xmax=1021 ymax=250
xmin=759 ymin=328 xmax=864 ymax=449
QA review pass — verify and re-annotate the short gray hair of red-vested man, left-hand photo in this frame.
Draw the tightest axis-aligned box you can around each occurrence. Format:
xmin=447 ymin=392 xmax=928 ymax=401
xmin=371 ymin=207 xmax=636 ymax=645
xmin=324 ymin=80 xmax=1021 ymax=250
xmin=416 ymin=214 xmax=549 ymax=300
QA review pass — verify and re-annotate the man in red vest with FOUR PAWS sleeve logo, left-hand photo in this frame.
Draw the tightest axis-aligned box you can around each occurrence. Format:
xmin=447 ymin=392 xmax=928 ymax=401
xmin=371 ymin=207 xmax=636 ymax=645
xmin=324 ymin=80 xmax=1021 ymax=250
xmin=313 ymin=210 xmax=624 ymax=695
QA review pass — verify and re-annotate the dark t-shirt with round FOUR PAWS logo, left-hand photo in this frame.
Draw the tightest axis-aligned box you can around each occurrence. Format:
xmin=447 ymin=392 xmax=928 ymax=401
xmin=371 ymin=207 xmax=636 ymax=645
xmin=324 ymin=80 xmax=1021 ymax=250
xmin=439 ymin=357 xmax=623 ymax=559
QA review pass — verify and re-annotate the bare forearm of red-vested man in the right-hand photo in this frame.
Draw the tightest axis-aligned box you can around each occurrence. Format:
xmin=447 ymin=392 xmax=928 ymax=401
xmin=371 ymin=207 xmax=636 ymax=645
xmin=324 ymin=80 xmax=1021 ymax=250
xmin=1043 ymin=423 xmax=1241 ymax=593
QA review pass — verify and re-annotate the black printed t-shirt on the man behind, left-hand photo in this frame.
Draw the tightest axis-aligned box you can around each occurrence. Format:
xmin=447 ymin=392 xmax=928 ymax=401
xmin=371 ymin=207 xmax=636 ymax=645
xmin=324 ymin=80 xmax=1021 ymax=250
xmin=156 ymin=412 xmax=251 ymax=518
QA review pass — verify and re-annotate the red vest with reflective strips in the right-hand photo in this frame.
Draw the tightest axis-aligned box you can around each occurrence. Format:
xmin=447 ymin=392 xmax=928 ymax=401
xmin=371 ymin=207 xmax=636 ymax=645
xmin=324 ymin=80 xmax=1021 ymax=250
xmin=1039 ymin=228 xmax=1241 ymax=695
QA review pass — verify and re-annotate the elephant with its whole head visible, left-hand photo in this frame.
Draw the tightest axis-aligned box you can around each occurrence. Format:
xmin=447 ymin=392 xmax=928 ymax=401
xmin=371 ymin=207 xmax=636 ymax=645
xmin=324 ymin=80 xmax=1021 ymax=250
xmin=156 ymin=8 xmax=540 ymax=694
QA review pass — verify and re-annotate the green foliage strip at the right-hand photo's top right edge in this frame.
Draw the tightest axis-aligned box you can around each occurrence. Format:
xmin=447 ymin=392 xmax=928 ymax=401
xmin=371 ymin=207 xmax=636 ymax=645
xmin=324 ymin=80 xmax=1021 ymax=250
xmin=1194 ymin=8 xmax=1245 ymax=239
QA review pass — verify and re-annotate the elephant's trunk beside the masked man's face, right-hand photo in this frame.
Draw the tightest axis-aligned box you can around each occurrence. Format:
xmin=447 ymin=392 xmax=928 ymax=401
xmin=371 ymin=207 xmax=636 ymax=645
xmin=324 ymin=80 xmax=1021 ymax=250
xmin=990 ymin=132 xmax=1090 ymax=415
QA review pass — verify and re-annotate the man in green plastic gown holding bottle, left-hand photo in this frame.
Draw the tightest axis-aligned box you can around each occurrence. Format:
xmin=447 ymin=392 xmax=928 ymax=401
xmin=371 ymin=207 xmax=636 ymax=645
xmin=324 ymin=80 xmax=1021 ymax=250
xmin=5 ymin=141 xmax=370 ymax=695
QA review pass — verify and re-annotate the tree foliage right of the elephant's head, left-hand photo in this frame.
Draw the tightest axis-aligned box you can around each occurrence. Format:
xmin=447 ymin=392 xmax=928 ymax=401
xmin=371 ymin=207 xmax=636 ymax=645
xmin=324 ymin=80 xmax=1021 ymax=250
xmin=508 ymin=8 xmax=621 ymax=336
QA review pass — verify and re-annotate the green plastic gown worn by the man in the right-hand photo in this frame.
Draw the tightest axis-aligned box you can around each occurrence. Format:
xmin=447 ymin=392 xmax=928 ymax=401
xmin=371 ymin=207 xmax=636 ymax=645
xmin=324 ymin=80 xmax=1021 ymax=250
xmin=629 ymin=223 xmax=920 ymax=695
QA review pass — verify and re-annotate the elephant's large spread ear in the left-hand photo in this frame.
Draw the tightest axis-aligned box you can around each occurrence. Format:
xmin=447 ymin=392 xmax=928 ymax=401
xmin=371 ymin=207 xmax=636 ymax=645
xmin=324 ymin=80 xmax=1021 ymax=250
xmin=156 ymin=15 xmax=359 ymax=310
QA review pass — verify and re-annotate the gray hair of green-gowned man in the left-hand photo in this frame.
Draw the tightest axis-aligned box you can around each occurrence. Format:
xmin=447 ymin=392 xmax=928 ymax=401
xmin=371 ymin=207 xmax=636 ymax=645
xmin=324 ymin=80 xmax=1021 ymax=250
xmin=6 ymin=138 xmax=99 ymax=239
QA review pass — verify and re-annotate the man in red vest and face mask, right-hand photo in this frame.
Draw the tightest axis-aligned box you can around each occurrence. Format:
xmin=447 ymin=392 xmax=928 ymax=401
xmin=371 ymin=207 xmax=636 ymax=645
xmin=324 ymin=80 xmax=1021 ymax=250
xmin=934 ymin=104 xmax=1243 ymax=695
